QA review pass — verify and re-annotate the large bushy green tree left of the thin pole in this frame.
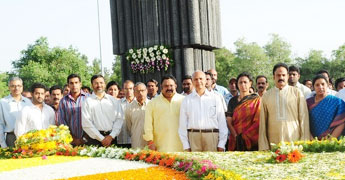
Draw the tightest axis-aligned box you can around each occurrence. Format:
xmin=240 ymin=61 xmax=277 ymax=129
xmin=12 ymin=37 xmax=91 ymax=88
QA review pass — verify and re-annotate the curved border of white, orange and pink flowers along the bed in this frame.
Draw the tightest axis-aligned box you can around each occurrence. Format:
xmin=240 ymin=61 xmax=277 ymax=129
xmin=79 ymin=147 xmax=241 ymax=180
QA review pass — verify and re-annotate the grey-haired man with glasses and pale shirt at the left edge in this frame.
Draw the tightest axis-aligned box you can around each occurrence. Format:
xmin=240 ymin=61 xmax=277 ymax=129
xmin=0 ymin=77 xmax=32 ymax=148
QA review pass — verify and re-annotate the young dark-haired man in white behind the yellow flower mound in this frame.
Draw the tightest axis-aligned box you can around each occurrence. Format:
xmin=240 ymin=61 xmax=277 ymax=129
xmin=14 ymin=83 xmax=55 ymax=138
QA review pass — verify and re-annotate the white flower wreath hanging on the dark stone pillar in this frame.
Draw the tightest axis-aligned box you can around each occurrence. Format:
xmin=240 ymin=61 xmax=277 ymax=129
xmin=126 ymin=45 xmax=173 ymax=74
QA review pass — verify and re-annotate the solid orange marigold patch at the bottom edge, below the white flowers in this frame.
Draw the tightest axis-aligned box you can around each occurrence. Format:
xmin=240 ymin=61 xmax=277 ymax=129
xmin=60 ymin=166 xmax=188 ymax=180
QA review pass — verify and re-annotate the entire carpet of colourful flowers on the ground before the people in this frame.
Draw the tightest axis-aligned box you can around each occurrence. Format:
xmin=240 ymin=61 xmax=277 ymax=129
xmin=0 ymin=127 xmax=345 ymax=180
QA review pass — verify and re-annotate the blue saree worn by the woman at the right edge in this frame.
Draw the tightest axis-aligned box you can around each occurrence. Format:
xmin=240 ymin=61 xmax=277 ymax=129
xmin=307 ymin=95 xmax=345 ymax=139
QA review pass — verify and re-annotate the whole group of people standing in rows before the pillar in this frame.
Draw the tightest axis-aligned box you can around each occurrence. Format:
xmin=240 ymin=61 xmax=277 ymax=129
xmin=0 ymin=63 xmax=345 ymax=152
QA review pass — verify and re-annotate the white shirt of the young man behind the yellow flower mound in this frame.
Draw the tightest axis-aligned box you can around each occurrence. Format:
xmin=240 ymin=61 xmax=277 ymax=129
xmin=14 ymin=103 xmax=55 ymax=137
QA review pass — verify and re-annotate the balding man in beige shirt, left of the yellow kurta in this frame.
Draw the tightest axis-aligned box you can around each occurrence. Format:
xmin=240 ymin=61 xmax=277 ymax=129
xmin=125 ymin=82 xmax=150 ymax=149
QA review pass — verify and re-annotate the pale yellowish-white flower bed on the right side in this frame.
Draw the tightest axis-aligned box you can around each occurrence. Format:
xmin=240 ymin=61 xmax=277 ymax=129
xmin=178 ymin=151 xmax=345 ymax=180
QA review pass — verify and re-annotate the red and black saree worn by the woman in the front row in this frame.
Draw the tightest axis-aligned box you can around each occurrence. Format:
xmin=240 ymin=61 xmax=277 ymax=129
xmin=228 ymin=96 xmax=260 ymax=151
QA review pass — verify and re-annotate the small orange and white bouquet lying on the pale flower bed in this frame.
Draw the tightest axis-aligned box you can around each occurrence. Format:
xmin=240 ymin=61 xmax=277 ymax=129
xmin=269 ymin=142 xmax=304 ymax=163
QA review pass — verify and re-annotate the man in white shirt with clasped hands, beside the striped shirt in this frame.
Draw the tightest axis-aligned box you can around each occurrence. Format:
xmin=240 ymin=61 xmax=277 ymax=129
xmin=81 ymin=75 xmax=123 ymax=147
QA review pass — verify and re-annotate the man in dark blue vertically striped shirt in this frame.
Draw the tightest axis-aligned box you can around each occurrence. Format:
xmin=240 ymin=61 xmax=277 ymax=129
xmin=56 ymin=74 xmax=89 ymax=146
